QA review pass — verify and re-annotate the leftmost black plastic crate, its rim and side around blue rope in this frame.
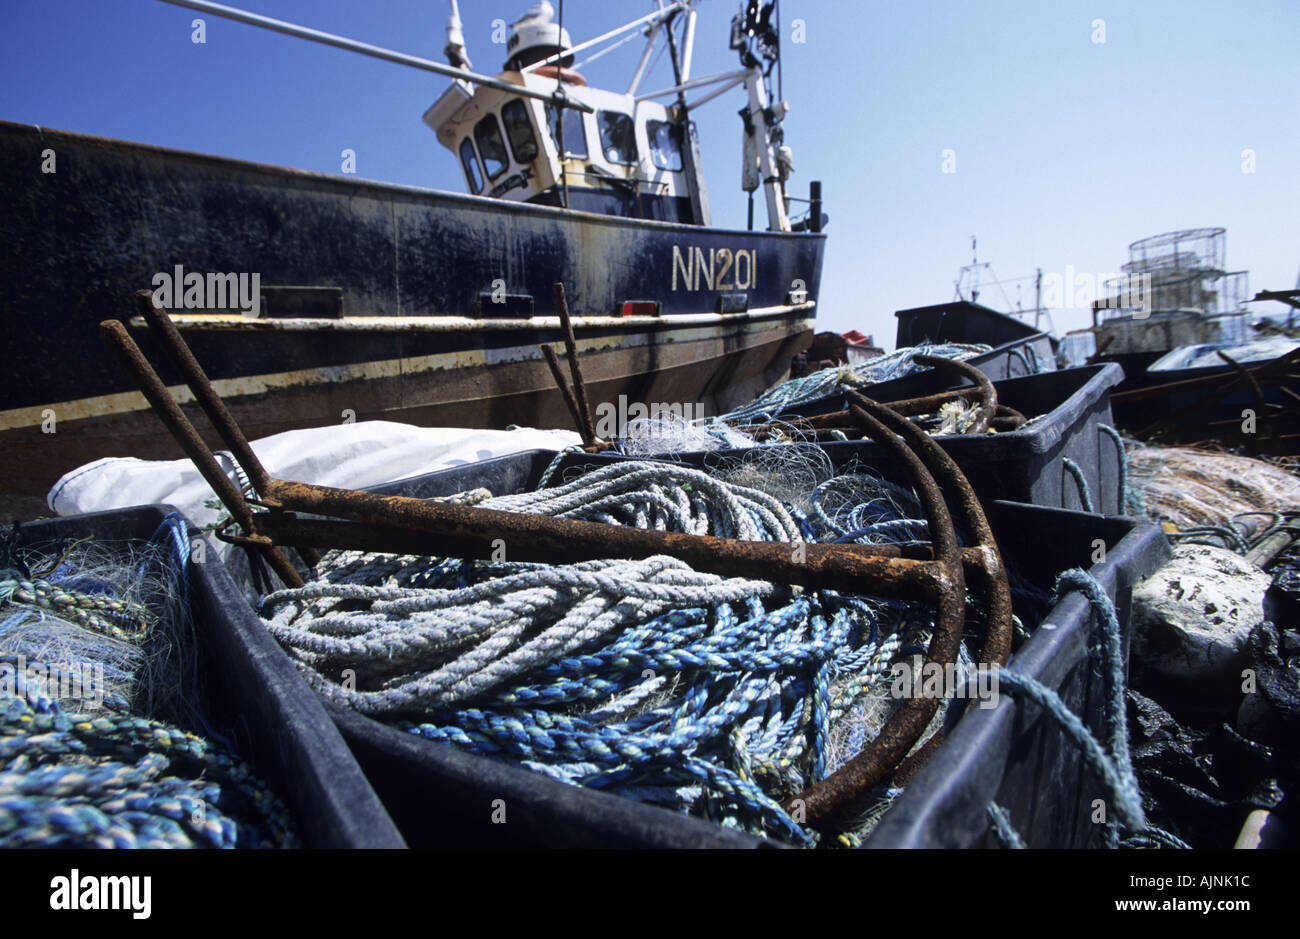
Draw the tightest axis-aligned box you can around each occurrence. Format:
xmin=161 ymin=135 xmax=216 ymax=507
xmin=7 ymin=506 xmax=406 ymax=848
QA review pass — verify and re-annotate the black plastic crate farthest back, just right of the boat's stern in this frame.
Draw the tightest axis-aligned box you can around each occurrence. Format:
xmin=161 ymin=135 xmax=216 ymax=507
xmin=894 ymin=300 xmax=1056 ymax=381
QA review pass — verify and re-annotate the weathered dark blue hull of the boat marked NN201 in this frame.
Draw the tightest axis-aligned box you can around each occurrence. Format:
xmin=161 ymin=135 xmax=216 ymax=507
xmin=0 ymin=122 xmax=824 ymax=504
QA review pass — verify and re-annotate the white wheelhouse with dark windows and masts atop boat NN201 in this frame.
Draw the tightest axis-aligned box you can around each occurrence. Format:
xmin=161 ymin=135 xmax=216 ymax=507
xmin=424 ymin=0 xmax=800 ymax=231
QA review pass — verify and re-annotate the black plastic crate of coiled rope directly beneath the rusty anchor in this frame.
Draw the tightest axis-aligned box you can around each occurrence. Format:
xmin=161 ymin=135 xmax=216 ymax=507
xmin=328 ymin=451 xmax=1169 ymax=848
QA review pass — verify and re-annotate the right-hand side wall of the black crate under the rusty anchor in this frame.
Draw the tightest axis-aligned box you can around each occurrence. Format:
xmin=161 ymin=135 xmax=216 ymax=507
xmin=865 ymin=502 xmax=1171 ymax=848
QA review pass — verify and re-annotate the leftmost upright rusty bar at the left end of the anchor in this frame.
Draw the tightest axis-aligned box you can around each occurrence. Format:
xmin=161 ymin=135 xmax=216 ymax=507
xmin=99 ymin=320 xmax=303 ymax=587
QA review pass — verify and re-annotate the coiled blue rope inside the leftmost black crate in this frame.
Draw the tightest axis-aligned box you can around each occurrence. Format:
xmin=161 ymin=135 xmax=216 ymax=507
xmin=0 ymin=514 xmax=296 ymax=848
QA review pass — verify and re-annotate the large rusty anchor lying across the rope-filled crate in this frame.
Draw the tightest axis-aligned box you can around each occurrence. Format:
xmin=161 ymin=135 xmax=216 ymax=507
xmin=100 ymin=290 xmax=1011 ymax=825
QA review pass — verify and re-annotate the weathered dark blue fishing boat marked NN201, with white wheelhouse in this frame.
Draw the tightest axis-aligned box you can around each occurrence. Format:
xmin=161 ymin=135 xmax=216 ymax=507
xmin=0 ymin=0 xmax=824 ymax=507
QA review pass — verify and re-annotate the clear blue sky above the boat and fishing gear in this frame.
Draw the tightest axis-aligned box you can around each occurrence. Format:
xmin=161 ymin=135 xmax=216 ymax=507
xmin=0 ymin=0 xmax=1300 ymax=347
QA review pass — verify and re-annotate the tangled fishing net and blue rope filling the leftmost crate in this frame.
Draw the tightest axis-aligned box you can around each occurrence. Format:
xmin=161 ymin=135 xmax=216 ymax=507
xmin=0 ymin=519 xmax=295 ymax=848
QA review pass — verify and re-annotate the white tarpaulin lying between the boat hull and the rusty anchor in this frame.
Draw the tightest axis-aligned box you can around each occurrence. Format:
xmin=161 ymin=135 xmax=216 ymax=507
xmin=46 ymin=420 xmax=582 ymax=527
